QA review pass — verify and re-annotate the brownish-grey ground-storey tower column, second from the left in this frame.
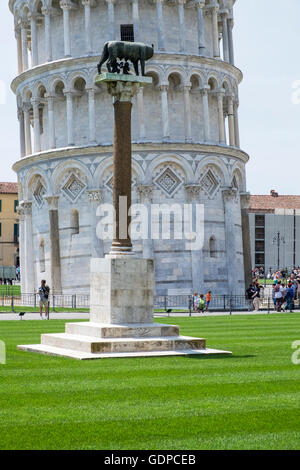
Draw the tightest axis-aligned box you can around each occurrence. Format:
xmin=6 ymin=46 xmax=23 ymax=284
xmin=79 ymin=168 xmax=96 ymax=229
xmin=44 ymin=196 xmax=62 ymax=295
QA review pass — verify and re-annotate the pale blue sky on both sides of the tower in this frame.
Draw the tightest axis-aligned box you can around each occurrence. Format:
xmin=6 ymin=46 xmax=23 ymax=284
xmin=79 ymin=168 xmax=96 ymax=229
xmin=0 ymin=0 xmax=300 ymax=194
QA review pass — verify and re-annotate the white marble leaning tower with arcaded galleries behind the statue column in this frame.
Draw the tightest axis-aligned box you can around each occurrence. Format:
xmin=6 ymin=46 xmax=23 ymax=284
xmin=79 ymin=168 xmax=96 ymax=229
xmin=9 ymin=0 xmax=249 ymax=295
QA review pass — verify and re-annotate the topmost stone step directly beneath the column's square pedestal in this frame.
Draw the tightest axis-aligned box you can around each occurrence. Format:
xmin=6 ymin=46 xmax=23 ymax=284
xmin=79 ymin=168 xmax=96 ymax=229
xmin=66 ymin=322 xmax=179 ymax=338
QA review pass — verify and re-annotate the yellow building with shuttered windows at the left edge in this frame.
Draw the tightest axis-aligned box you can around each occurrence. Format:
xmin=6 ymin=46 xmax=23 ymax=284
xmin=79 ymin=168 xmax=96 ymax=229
xmin=0 ymin=182 xmax=19 ymax=279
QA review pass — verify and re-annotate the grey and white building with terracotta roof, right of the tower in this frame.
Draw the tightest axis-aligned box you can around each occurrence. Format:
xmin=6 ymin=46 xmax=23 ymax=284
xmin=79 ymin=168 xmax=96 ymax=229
xmin=249 ymin=191 xmax=300 ymax=274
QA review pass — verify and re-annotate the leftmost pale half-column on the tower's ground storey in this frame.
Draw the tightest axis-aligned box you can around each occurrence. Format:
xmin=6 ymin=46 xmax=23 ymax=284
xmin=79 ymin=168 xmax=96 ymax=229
xmin=20 ymin=201 xmax=36 ymax=294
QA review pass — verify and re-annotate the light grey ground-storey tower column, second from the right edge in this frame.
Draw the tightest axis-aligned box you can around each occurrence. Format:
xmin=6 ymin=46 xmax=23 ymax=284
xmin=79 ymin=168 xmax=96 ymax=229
xmin=222 ymin=188 xmax=238 ymax=294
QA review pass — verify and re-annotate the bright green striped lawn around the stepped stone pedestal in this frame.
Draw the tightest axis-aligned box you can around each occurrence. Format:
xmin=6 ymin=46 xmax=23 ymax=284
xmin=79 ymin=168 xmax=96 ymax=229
xmin=0 ymin=314 xmax=300 ymax=450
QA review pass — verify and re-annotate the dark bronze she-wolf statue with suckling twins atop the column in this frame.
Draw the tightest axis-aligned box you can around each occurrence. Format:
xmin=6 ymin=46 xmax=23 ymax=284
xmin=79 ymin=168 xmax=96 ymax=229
xmin=98 ymin=41 xmax=154 ymax=76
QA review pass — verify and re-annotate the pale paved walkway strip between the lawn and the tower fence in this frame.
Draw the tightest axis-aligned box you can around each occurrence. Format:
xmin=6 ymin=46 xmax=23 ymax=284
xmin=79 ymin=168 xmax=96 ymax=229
xmin=0 ymin=310 xmax=300 ymax=321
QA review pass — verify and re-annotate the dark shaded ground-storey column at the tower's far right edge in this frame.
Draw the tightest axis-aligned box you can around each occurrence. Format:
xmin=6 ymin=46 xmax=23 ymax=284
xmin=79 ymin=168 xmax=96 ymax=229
xmin=240 ymin=193 xmax=252 ymax=288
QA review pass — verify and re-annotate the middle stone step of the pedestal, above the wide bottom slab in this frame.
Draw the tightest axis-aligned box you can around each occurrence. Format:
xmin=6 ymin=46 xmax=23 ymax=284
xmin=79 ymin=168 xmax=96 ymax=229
xmin=41 ymin=333 xmax=206 ymax=353
